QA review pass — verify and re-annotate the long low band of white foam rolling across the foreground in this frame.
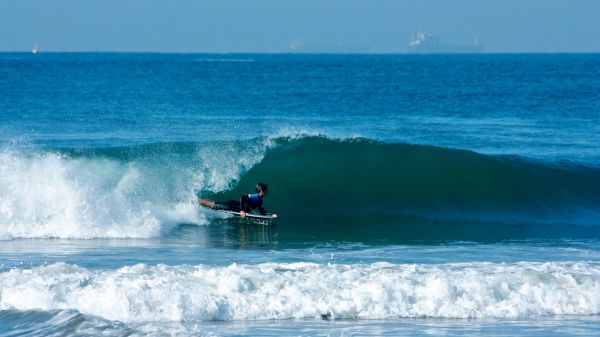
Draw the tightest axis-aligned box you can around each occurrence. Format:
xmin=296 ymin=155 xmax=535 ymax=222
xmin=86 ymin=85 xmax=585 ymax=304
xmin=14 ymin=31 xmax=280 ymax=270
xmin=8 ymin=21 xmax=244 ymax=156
xmin=0 ymin=262 xmax=600 ymax=322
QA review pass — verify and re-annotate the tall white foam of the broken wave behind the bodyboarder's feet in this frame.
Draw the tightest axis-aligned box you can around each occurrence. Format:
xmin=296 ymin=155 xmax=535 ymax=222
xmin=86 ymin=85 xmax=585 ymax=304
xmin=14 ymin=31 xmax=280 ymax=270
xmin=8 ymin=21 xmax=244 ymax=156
xmin=0 ymin=150 xmax=206 ymax=240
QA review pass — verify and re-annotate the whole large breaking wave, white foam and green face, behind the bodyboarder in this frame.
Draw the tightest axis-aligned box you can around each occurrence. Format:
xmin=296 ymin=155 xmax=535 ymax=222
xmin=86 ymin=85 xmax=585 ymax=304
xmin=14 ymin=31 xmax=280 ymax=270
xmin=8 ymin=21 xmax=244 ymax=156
xmin=0 ymin=136 xmax=600 ymax=241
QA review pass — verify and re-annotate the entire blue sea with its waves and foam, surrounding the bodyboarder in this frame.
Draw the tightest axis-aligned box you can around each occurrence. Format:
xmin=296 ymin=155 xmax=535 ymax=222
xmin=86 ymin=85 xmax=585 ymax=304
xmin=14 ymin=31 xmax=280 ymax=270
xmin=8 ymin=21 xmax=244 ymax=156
xmin=0 ymin=53 xmax=600 ymax=336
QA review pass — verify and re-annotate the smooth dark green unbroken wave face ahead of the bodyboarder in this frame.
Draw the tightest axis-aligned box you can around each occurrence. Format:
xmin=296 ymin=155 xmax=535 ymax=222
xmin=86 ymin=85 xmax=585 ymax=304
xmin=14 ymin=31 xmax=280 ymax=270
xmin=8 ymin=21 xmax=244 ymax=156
xmin=217 ymin=137 xmax=600 ymax=240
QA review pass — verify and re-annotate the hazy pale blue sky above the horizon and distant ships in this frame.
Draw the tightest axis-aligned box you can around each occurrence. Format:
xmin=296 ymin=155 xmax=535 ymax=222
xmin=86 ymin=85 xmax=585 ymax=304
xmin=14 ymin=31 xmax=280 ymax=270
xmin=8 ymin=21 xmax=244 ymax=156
xmin=0 ymin=0 xmax=600 ymax=53
